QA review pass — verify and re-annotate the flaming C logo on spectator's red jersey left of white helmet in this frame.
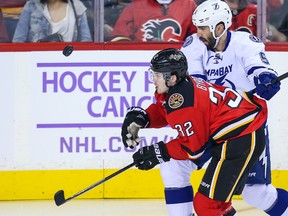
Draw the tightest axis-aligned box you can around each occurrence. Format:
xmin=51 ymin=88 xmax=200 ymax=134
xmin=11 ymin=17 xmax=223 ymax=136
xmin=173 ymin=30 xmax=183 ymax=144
xmin=141 ymin=19 xmax=182 ymax=42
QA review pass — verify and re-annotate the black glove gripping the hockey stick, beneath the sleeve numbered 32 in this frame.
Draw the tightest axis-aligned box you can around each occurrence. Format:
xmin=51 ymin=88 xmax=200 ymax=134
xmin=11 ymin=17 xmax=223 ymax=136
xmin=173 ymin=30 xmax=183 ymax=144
xmin=133 ymin=141 xmax=171 ymax=170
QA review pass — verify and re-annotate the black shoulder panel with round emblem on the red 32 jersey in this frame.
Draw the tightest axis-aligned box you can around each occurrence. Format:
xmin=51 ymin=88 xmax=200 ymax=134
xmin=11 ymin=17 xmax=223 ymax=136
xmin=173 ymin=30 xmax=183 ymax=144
xmin=165 ymin=79 xmax=194 ymax=113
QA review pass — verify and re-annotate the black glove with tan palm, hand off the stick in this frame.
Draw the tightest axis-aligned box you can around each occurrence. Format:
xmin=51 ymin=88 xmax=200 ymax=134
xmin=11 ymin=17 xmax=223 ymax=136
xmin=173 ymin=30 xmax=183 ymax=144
xmin=121 ymin=107 xmax=149 ymax=149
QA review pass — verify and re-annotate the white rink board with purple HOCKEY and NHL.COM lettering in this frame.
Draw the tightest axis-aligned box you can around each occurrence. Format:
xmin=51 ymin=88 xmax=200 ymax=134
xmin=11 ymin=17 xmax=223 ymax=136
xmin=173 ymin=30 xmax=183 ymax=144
xmin=0 ymin=51 xmax=288 ymax=170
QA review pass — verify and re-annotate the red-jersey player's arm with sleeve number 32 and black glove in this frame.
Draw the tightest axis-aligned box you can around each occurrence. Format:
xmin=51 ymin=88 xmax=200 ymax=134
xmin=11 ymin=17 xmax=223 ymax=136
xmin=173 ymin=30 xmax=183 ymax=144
xmin=133 ymin=106 xmax=207 ymax=170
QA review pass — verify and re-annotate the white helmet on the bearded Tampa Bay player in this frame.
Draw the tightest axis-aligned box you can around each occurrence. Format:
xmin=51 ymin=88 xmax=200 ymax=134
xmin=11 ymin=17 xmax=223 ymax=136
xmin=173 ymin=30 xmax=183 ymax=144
xmin=192 ymin=0 xmax=232 ymax=39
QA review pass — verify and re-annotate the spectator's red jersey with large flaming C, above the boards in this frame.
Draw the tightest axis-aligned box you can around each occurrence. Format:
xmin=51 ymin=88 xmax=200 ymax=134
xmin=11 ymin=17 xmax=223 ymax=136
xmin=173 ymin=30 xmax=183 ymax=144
xmin=112 ymin=0 xmax=197 ymax=42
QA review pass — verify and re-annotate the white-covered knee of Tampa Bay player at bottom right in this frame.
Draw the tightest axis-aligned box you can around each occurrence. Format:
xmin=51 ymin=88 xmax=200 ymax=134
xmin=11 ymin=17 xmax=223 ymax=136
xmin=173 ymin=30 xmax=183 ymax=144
xmin=242 ymin=184 xmax=277 ymax=210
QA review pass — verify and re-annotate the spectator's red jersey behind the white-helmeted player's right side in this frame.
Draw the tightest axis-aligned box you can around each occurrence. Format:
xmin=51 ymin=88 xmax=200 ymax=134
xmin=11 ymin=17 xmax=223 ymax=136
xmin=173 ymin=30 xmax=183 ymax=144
xmin=230 ymin=4 xmax=257 ymax=36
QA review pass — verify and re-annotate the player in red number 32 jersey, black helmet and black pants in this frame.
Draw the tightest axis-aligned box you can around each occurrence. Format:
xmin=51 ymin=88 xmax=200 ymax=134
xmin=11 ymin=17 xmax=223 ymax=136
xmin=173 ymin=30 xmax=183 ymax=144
xmin=121 ymin=48 xmax=267 ymax=216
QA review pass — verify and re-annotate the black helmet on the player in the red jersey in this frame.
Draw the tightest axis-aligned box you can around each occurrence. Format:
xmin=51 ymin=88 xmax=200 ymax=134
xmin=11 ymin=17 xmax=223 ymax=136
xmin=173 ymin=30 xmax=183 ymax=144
xmin=150 ymin=48 xmax=188 ymax=81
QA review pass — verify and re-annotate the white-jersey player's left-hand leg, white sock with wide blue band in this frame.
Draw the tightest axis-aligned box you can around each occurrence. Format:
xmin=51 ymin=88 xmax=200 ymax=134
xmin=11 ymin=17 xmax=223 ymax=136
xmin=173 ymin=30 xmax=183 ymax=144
xmin=160 ymin=159 xmax=197 ymax=216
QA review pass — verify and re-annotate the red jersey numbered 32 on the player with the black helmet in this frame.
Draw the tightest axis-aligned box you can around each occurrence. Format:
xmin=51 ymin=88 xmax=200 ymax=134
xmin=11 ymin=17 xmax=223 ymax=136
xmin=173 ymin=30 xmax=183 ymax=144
xmin=146 ymin=78 xmax=267 ymax=160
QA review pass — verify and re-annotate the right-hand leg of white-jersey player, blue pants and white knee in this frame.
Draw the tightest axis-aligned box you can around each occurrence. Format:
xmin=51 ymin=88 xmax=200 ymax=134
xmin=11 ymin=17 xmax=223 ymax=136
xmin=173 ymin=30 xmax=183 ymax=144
xmin=242 ymin=124 xmax=288 ymax=216
